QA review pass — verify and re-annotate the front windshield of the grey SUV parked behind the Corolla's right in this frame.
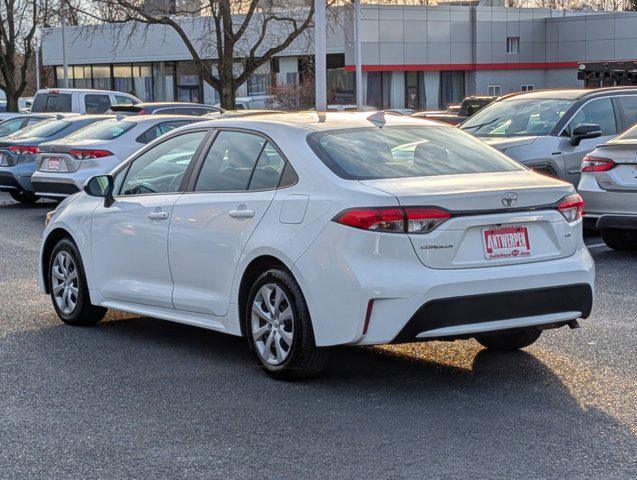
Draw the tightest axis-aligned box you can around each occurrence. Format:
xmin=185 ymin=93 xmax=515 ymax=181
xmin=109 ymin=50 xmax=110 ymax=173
xmin=460 ymin=97 xmax=573 ymax=137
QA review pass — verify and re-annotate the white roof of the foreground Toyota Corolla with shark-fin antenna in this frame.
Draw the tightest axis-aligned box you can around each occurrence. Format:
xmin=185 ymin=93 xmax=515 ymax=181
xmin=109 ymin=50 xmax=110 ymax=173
xmin=193 ymin=112 xmax=442 ymax=132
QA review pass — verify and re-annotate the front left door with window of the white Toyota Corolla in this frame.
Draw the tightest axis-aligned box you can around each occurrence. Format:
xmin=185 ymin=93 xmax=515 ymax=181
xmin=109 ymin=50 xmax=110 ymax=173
xmin=91 ymin=130 xmax=208 ymax=308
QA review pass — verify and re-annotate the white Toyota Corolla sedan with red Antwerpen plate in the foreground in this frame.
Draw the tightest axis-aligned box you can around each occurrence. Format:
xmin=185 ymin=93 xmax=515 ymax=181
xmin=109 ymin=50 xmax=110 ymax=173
xmin=40 ymin=113 xmax=594 ymax=378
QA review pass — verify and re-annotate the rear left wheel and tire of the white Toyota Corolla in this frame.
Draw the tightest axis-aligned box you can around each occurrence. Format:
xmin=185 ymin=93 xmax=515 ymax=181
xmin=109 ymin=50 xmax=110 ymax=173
xmin=244 ymin=268 xmax=328 ymax=380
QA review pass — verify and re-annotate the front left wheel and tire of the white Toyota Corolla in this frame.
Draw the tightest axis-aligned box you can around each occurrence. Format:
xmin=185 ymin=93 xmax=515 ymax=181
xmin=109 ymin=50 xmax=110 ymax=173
xmin=47 ymin=238 xmax=108 ymax=326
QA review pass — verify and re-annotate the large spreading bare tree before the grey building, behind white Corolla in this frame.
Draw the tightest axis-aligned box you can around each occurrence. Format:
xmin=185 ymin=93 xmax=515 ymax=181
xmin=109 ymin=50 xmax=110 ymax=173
xmin=74 ymin=0 xmax=314 ymax=109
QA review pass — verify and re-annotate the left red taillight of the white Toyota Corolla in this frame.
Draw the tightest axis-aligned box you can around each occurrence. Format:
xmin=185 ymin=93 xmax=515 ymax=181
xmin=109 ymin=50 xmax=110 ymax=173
xmin=334 ymin=207 xmax=451 ymax=233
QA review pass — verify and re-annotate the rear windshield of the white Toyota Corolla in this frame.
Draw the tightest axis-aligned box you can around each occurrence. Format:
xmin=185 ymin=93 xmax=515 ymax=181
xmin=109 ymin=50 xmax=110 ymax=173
xmin=307 ymin=126 xmax=524 ymax=180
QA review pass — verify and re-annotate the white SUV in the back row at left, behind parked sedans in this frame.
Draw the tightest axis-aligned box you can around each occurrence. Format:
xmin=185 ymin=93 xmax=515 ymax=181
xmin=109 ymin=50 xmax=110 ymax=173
xmin=31 ymin=88 xmax=141 ymax=114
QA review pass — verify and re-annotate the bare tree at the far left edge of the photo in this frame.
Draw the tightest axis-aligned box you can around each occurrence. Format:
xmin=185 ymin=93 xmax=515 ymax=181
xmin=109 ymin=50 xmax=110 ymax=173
xmin=0 ymin=0 xmax=48 ymax=112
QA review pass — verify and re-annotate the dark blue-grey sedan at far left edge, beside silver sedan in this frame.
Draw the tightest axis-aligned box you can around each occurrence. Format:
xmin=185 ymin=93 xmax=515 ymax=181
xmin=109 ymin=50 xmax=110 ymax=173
xmin=0 ymin=115 xmax=113 ymax=203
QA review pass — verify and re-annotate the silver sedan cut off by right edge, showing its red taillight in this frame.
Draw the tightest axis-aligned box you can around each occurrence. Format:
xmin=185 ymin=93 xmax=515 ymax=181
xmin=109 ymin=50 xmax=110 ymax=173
xmin=578 ymin=125 xmax=637 ymax=250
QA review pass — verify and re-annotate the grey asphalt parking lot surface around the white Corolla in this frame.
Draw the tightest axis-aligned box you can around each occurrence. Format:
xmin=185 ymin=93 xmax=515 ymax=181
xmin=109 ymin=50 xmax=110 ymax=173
xmin=0 ymin=194 xmax=637 ymax=479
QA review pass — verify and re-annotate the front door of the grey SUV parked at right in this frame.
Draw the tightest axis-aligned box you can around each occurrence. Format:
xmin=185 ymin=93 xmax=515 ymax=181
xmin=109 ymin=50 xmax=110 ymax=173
xmin=559 ymin=97 xmax=618 ymax=185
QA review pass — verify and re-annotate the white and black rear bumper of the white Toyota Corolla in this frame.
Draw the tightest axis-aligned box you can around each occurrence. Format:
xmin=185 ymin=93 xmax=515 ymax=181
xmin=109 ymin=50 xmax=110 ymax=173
xmin=293 ymin=225 xmax=595 ymax=346
